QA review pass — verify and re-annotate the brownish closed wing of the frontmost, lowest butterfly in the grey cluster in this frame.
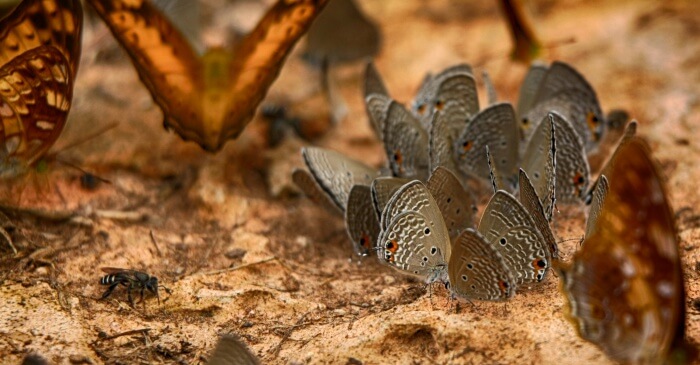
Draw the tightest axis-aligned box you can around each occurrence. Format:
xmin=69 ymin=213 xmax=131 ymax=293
xmin=447 ymin=229 xmax=516 ymax=301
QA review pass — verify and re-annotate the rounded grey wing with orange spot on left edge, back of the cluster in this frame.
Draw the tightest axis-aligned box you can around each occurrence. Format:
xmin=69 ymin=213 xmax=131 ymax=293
xmin=454 ymin=103 xmax=520 ymax=180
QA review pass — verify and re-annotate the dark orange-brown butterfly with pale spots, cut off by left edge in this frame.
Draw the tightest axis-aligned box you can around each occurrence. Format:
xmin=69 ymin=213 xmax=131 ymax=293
xmin=0 ymin=0 xmax=82 ymax=178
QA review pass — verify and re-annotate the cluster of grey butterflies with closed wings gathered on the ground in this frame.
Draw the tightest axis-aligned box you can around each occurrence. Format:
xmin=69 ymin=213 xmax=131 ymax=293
xmin=293 ymin=62 xmax=636 ymax=301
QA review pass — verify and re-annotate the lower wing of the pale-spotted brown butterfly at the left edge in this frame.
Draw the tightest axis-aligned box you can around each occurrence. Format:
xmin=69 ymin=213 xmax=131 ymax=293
xmin=0 ymin=46 xmax=73 ymax=177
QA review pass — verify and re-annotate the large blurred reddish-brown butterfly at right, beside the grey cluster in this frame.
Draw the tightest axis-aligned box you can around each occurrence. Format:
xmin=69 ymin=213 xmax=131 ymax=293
xmin=558 ymin=137 xmax=688 ymax=364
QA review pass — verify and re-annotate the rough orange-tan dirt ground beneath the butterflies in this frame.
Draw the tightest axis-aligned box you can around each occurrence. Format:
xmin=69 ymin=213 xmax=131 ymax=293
xmin=0 ymin=0 xmax=700 ymax=364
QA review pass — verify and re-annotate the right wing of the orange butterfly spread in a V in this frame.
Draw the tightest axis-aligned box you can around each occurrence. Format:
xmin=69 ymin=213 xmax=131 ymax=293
xmin=224 ymin=0 xmax=328 ymax=144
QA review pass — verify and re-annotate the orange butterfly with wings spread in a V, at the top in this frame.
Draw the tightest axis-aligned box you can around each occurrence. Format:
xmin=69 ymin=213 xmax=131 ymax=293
xmin=88 ymin=0 xmax=328 ymax=152
